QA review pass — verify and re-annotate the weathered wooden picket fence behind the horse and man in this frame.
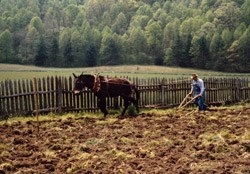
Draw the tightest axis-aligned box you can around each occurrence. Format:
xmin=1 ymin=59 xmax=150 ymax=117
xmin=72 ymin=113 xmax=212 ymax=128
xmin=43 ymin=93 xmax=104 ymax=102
xmin=0 ymin=77 xmax=250 ymax=119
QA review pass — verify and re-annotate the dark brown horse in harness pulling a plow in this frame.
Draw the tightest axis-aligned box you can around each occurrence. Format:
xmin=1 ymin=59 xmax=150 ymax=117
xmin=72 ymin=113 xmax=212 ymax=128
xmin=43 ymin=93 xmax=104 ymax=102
xmin=73 ymin=73 xmax=140 ymax=117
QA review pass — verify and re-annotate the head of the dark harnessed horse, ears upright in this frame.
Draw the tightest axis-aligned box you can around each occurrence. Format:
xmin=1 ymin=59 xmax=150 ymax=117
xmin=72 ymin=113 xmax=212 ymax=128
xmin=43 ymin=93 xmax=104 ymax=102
xmin=73 ymin=73 xmax=94 ymax=94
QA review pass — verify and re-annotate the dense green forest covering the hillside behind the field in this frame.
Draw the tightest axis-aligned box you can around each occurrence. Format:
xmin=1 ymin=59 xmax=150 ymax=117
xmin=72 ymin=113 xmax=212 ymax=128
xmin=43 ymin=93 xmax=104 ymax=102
xmin=0 ymin=0 xmax=250 ymax=73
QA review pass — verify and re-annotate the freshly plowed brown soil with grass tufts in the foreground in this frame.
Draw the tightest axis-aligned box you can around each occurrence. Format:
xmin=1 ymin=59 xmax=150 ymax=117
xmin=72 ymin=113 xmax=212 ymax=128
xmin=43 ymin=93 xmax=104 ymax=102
xmin=0 ymin=107 xmax=250 ymax=174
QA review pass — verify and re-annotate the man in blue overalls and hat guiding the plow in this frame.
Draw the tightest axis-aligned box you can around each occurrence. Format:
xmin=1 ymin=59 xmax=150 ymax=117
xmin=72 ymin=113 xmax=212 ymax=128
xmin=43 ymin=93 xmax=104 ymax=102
xmin=189 ymin=74 xmax=206 ymax=111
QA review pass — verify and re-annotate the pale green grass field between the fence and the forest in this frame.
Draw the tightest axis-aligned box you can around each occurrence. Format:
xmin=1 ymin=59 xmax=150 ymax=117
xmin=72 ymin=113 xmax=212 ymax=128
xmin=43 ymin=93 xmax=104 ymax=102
xmin=0 ymin=64 xmax=250 ymax=81
